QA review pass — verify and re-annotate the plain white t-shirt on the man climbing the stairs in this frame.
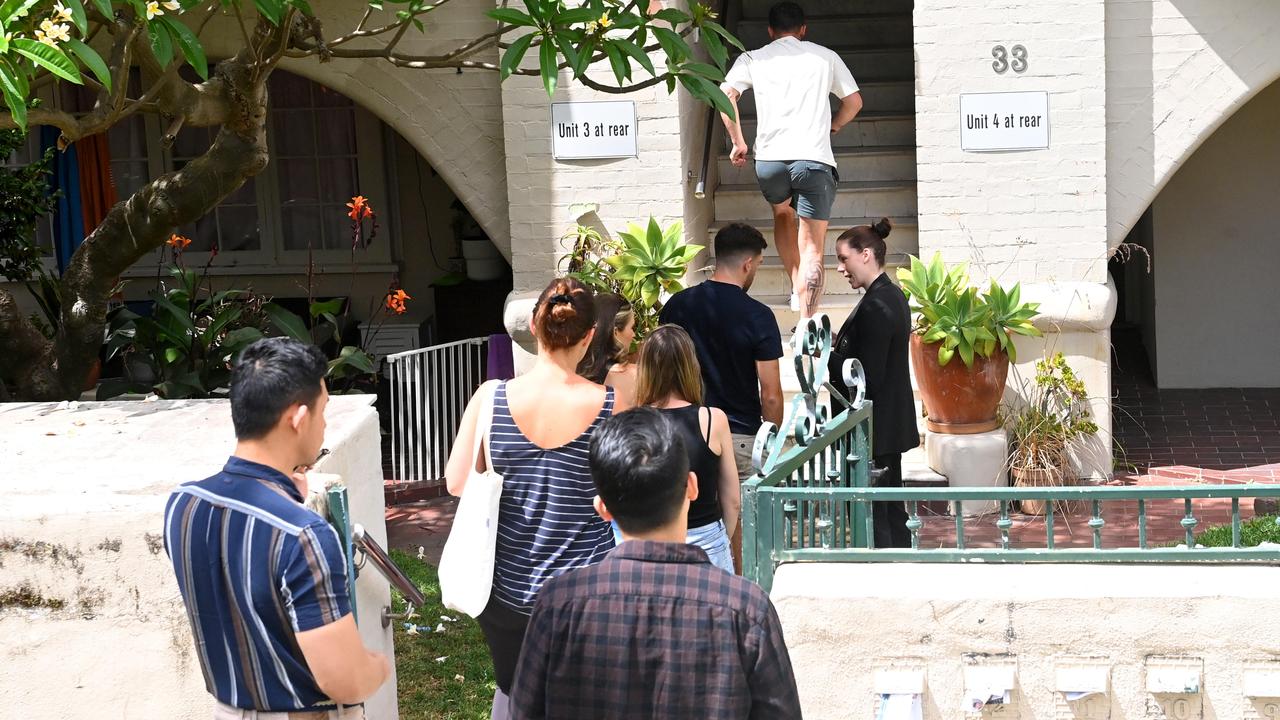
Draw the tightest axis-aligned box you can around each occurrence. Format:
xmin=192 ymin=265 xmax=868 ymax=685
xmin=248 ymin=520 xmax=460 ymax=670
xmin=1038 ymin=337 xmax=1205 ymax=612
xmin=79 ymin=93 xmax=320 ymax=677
xmin=721 ymin=36 xmax=858 ymax=167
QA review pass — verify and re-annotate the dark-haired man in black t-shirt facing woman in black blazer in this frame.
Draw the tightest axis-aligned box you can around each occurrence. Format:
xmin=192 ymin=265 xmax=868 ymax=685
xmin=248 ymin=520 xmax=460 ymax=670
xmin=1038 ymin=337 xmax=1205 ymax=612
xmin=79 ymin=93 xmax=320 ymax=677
xmin=658 ymin=223 xmax=782 ymax=566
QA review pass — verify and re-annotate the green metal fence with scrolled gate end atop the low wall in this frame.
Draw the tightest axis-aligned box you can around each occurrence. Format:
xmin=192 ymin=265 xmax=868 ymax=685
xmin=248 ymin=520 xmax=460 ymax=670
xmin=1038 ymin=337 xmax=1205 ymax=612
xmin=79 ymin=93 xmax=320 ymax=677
xmin=742 ymin=315 xmax=1280 ymax=589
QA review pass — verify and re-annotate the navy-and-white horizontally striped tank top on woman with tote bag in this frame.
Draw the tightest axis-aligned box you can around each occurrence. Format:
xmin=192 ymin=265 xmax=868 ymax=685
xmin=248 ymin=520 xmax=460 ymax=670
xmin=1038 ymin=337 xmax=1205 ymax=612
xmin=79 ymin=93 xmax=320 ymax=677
xmin=489 ymin=382 xmax=613 ymax=607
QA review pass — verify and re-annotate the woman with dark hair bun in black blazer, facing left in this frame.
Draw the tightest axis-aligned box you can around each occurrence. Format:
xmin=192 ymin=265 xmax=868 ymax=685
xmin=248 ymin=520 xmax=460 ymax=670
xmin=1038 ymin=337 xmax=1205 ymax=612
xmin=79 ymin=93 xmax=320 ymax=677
xmin=828 ymin=218 xmax=920 ymax=547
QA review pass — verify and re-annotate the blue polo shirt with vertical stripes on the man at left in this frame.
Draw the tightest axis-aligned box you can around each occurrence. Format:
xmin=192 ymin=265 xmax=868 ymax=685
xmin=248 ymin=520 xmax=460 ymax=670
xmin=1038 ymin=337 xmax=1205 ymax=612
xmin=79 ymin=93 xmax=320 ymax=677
xmin=164 ymin=457 xmax=351 ymax=711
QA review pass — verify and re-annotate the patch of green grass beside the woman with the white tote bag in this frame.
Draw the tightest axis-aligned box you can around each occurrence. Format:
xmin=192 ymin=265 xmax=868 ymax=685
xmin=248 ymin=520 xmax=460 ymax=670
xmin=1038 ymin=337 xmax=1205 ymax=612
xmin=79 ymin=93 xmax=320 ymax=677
xmin=390 ymin=550 xmax=497 ymax=720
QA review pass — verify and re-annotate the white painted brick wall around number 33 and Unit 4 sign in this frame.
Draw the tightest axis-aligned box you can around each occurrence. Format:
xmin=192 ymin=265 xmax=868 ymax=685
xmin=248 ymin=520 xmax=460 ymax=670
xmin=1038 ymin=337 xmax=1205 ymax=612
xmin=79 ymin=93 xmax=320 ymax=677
xmin=915 ymin=0 xmax=1107 ymax=283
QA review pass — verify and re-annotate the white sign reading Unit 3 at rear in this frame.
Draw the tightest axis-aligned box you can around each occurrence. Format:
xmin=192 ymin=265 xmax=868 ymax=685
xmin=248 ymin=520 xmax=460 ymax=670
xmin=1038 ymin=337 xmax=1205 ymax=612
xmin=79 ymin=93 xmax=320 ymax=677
xmin=552 ymin=101 xmax=636 ymax=160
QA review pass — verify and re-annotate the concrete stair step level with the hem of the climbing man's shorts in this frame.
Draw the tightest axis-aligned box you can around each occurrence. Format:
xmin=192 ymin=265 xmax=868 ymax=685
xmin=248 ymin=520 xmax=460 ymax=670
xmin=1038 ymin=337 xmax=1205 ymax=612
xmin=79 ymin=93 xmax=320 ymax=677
xmin=716 ymin=179 xmax=916 ymax=223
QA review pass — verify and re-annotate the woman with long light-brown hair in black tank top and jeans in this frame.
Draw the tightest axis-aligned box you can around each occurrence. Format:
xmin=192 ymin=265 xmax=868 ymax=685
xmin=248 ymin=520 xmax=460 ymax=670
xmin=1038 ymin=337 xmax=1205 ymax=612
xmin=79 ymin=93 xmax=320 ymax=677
xmin=636 ymin=325 xmax=742 ymax=573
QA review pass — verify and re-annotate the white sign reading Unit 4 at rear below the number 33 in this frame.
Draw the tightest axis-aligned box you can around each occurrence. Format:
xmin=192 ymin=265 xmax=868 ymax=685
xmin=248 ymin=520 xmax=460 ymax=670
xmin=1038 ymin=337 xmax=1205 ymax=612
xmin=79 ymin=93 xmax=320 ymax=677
xmin=960 ymin=92 xmax=1048 ymax=152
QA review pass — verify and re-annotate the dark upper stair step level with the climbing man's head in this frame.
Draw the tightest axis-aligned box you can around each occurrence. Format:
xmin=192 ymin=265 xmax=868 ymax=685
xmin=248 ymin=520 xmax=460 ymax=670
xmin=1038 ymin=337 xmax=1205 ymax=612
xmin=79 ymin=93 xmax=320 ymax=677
xmin=736 ymin=13 xmax=915 ymax=50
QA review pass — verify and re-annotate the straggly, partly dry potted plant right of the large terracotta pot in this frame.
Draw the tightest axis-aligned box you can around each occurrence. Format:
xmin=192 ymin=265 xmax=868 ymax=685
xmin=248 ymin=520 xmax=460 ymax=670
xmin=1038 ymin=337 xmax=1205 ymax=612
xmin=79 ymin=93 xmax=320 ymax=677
xmin=1004 ymin=352 xmax=1098 ymax=515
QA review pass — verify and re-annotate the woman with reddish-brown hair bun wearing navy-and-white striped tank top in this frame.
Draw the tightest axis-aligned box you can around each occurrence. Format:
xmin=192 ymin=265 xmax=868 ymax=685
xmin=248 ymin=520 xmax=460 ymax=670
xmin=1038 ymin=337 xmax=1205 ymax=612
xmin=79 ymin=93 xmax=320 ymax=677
xmin=445 ymin=278 xmax=613 ymax=717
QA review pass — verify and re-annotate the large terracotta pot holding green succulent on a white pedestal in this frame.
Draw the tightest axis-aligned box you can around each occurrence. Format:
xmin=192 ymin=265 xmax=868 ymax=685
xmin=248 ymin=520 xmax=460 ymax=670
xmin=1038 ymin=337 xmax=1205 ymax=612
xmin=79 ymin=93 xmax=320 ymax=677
xmin=911 ymin=333 xmax=1009 ymax=434
